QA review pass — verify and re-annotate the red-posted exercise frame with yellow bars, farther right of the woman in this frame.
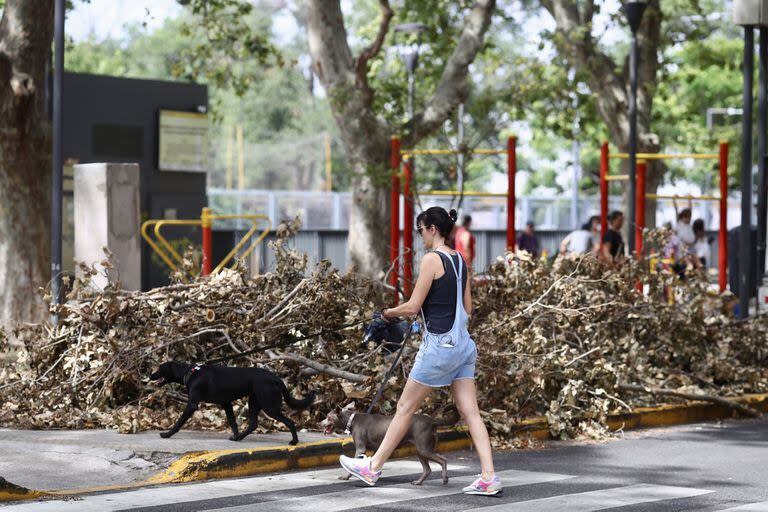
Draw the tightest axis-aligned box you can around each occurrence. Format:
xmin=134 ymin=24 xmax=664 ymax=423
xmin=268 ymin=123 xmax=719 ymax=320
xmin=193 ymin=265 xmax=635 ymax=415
xmin=600 ymin=141 xmax=728 ymax=293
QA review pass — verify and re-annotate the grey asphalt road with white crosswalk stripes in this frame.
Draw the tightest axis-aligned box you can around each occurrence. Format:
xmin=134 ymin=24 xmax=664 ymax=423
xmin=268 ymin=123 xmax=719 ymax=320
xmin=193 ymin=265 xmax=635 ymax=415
xmin=0 ymin=420 xmax=768 ymax=512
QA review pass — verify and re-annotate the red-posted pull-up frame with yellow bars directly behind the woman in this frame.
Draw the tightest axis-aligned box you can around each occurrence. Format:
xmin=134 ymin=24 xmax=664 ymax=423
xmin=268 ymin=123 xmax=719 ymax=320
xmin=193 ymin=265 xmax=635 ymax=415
xmin=389 ymin=136 xmax=517 ymax=304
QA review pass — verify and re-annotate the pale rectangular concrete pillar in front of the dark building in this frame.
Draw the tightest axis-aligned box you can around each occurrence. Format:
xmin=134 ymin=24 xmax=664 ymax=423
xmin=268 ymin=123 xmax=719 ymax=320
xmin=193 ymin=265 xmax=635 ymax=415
xmin=75 ymin=163 xmax=141 ymax=290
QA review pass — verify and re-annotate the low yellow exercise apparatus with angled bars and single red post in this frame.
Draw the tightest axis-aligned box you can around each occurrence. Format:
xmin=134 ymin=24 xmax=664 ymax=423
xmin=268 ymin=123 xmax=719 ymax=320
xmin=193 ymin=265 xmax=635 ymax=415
xmin=141 ymin=208 xmax=272 ymax=276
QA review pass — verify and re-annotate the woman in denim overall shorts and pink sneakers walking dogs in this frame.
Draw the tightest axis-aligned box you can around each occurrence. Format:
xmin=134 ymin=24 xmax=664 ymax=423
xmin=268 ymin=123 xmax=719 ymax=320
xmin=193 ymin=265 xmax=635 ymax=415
xmin=339 ymin=206 xmax=501 ymax=495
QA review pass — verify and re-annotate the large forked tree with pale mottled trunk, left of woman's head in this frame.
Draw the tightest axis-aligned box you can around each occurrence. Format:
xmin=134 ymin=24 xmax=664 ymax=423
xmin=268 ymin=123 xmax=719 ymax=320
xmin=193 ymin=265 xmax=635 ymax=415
xmin=307 ymin=0 xmax=496 ymax=274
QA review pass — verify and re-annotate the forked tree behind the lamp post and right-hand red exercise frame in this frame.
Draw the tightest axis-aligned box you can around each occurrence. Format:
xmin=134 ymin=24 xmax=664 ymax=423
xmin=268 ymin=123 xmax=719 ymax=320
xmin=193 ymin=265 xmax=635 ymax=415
xmin=541 ymin=0 xmax=724 ymax=226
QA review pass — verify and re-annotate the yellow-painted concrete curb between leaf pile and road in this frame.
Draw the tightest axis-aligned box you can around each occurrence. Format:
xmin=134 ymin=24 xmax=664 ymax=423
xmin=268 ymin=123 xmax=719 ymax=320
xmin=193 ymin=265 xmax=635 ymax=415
xmin=0 ymin=394 xmax=768 ymax=502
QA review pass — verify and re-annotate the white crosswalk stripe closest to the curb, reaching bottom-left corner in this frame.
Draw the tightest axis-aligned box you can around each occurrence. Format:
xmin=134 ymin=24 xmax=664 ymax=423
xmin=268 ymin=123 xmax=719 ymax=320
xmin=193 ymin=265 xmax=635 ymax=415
xmin=0 ymin=460 xmax=468 ymax=512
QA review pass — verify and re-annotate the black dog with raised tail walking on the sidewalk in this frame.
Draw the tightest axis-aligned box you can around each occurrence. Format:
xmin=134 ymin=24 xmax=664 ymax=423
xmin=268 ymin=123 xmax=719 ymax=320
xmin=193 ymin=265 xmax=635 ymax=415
xmin=150 ymin=361 xmax=315 ymax=445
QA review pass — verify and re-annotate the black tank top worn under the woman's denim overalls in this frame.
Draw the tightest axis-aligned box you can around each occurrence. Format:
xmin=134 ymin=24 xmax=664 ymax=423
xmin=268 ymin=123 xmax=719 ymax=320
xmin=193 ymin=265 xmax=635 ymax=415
xmin=421 ymin=251 xmax=467 ymax=334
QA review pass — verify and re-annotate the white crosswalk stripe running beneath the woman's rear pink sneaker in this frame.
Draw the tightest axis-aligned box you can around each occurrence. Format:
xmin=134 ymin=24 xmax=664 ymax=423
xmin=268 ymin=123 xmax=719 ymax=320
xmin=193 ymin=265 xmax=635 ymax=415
xmin=209 ymin=470 xmax=575 ymax=512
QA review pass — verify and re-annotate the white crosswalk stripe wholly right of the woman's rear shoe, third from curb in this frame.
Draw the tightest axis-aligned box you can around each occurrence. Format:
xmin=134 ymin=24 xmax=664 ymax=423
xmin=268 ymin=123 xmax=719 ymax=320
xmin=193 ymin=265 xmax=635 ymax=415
xmin=460 ymin=484 xmax=713 ymax=512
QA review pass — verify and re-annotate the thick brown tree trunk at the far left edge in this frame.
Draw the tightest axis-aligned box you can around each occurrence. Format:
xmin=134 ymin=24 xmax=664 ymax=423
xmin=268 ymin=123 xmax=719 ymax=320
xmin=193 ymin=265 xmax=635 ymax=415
xmin=0 ymin=0 xmax=53 ymax=336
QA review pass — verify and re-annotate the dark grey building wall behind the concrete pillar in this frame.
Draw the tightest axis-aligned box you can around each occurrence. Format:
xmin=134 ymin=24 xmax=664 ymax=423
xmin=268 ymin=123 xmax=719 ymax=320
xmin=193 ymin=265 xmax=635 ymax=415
xmin=63 ymin=73 xmax=208 ymax=289
